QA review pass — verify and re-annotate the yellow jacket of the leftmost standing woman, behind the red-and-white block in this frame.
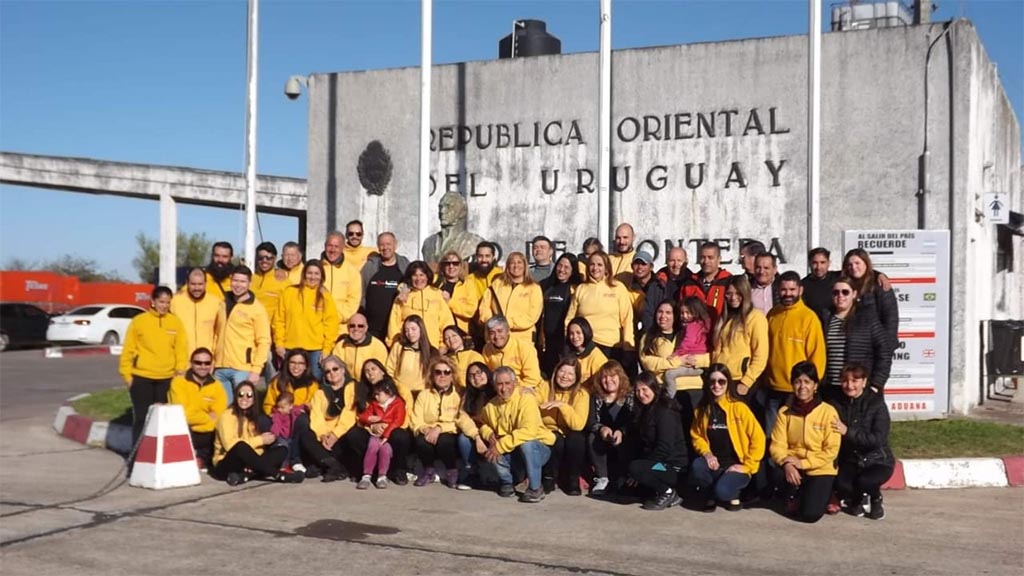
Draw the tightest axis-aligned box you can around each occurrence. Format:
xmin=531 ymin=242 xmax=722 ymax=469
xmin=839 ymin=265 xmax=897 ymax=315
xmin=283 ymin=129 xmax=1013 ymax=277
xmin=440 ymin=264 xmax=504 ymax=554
xmin=118 ymin=308 xmax=190 ymax=384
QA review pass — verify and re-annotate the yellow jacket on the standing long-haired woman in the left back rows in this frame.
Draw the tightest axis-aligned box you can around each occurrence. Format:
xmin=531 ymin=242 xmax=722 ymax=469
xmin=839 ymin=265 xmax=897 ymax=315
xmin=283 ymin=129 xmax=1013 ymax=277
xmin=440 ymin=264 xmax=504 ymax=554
xmin=273 ymin=286 xmax=338 ymax=356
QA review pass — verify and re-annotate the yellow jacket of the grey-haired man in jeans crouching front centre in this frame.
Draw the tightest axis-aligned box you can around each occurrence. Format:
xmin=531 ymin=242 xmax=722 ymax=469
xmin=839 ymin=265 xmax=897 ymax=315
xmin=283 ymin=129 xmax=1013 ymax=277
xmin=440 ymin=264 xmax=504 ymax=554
xmin=480 ymin=387 xmax=555 ymax=454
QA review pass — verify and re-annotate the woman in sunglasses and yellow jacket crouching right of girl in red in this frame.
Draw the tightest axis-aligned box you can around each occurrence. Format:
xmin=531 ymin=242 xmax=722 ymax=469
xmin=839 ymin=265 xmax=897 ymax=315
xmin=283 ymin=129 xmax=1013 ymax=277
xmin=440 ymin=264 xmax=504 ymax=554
xmin=410 ymin=357 xmax=479 ymax=488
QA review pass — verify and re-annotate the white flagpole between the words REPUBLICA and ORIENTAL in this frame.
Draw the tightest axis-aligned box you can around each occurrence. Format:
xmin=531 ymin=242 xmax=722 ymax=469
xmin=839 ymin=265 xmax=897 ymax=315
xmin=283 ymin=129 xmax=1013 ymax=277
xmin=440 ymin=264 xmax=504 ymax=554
xmin=597 ymin=0 xmax=611 ymax=246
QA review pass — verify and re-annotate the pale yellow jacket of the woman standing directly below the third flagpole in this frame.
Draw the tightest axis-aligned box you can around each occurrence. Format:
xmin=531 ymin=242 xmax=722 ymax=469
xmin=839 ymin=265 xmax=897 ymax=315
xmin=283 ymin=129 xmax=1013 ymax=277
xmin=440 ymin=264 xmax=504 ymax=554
xmin=565 ymin=281 xmax=634 ymax=349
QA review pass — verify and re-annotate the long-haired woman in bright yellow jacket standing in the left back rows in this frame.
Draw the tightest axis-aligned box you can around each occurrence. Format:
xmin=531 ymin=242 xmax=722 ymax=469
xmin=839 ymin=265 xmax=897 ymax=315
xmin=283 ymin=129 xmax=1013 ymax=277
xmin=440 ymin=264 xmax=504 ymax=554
xmin=273 ymin=260 xmax=338 ymax=380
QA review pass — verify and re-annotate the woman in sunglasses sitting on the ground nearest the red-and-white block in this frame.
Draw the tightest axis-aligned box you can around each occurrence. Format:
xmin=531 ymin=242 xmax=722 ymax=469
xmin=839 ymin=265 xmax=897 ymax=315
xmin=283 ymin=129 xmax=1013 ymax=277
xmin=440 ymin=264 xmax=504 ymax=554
xmin=213 ymin=380 xmax=303 ymax=486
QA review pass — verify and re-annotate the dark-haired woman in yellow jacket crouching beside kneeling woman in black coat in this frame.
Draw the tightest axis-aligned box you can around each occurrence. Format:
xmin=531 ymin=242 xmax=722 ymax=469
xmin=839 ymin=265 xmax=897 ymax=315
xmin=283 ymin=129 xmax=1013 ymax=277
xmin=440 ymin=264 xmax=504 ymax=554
xmin=770 ymin=361 xmax=843 ymax=523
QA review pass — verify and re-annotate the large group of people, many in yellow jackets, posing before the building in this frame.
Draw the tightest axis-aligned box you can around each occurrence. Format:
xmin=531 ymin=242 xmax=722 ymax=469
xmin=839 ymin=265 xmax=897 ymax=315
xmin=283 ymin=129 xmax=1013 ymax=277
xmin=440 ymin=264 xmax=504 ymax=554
xmin=120 ymin=220 xmax=899 ymax=522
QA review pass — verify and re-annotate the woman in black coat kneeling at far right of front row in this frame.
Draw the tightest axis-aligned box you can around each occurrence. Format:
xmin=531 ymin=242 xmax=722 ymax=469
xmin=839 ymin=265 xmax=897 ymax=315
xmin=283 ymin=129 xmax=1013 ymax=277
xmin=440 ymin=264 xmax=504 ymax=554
xmin=830 ymin=363 xmax=895 ymax=520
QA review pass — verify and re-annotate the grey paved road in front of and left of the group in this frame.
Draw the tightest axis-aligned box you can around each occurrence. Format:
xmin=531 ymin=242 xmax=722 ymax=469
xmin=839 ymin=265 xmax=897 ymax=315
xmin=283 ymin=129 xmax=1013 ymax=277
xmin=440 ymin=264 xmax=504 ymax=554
xmin=0 ymin=352 xmax=1024 ymax=576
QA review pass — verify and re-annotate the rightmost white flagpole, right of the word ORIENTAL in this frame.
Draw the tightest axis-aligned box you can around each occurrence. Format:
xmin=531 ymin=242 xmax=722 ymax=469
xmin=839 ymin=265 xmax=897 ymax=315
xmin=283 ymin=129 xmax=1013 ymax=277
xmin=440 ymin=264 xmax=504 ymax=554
xmin=807 ymin=0 xmax=821 ymax=250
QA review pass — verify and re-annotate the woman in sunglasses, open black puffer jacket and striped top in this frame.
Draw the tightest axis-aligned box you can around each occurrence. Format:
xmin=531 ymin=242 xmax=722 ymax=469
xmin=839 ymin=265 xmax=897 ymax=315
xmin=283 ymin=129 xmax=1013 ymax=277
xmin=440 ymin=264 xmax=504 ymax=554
xmin=820 ymin=276 xmax=893 ymax=393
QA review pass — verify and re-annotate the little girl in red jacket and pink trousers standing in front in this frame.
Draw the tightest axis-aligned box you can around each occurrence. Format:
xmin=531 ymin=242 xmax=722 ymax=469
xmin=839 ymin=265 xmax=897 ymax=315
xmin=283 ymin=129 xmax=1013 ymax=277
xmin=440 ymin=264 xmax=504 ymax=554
xmin=355 ymin=378 xmax=406 ymax=490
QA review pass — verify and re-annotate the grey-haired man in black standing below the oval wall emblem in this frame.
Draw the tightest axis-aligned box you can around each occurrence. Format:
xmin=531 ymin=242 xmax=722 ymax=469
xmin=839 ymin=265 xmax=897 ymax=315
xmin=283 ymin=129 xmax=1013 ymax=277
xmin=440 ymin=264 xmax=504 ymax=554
xmin=360 ymin=232 xmax=409 ymax=340
